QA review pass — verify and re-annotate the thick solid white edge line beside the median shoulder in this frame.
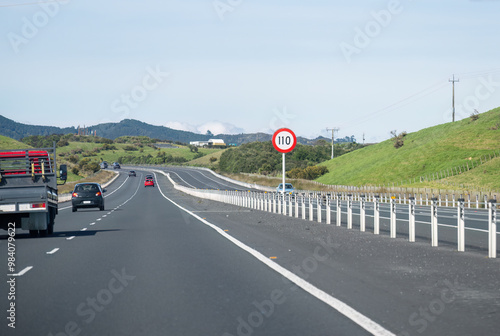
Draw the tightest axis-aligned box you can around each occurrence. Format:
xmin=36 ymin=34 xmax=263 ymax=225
xmin=154 ymin=173 xmax=395 ymax=336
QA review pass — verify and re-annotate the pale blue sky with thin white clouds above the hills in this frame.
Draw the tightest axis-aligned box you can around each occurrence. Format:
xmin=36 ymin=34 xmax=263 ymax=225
xmin=0 ymin=0 xmax=500 ymax=143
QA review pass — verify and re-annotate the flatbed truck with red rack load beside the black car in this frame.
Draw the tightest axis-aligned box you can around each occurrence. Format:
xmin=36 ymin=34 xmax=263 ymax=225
xmin=0 ymin=144 xmax=67 ymax=237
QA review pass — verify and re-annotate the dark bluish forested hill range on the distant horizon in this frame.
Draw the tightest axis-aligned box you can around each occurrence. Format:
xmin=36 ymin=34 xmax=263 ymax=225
xmin=0 ymin=115 xmax=328 ymax=145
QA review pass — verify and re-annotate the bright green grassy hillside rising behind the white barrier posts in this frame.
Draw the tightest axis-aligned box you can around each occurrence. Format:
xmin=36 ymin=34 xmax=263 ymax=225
xmin=316 ymin=108 xmax=500 ymax=190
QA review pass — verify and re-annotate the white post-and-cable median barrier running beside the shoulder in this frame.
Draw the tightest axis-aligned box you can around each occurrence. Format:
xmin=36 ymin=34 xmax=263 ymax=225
xmin=157 ymin=171 xmax=498 ymax=258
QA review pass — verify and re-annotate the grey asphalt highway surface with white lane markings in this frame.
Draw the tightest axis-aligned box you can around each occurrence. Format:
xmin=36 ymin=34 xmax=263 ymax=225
xmin=0 ymin=168 xmax=500 ymax=336
